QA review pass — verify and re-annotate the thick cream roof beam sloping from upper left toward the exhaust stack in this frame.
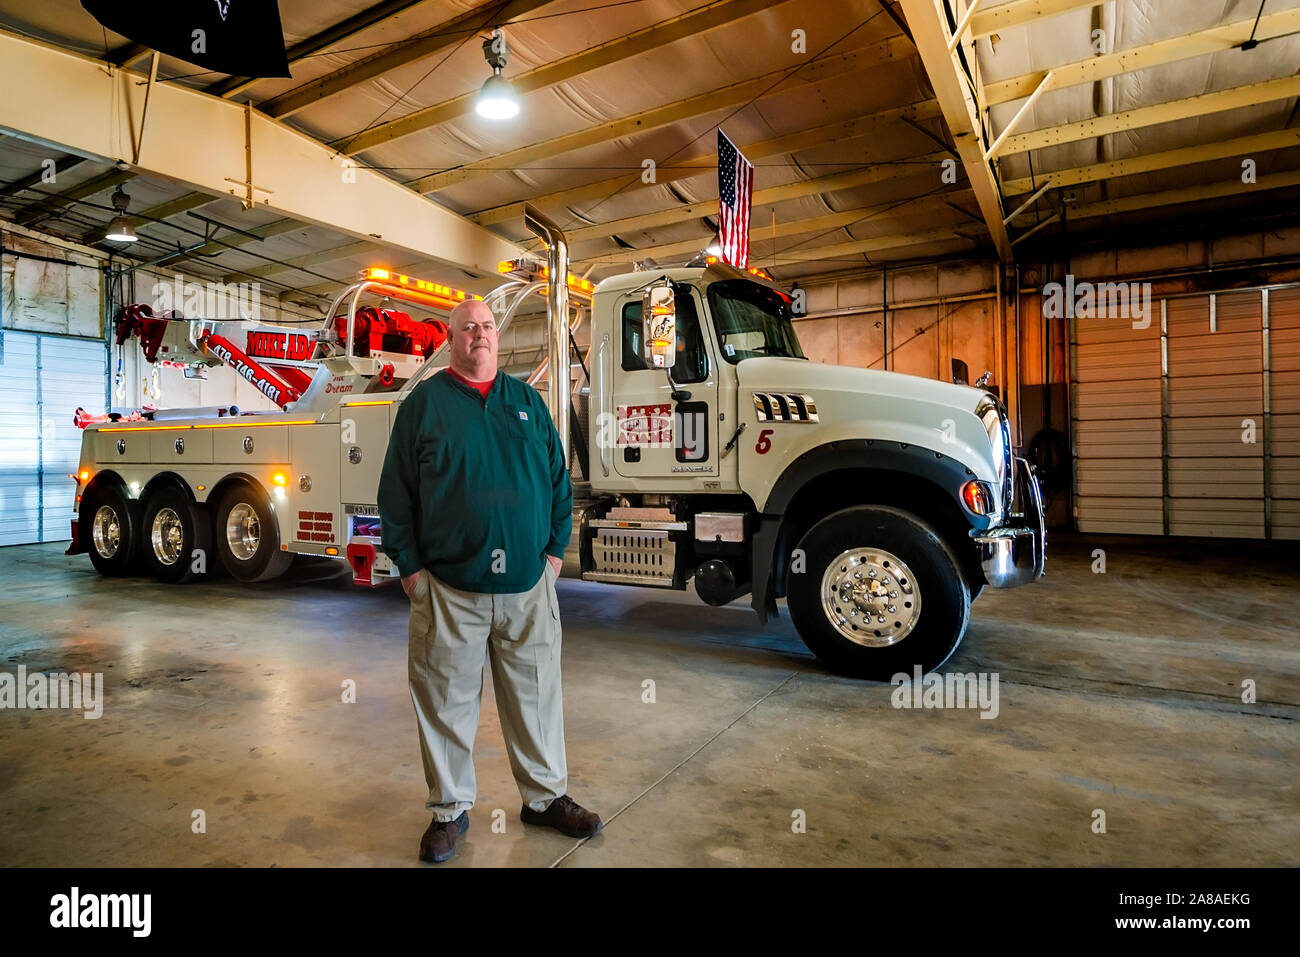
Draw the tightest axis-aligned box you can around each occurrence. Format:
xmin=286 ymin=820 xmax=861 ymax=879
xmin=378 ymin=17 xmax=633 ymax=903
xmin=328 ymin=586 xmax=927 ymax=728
xmin=0 ymin=33 xmax=521 ymax=276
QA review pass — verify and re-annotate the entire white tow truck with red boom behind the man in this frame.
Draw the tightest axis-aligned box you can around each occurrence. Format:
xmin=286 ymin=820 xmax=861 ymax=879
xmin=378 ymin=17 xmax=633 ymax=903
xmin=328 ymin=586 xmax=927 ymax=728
xmin=69 ymin=209 xmax=1045 ymax=680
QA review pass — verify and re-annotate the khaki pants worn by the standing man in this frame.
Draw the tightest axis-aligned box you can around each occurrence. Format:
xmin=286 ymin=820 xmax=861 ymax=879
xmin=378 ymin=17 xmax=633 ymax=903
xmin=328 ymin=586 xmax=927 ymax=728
xmin=407 ymin=562 xmax=568 ymax=820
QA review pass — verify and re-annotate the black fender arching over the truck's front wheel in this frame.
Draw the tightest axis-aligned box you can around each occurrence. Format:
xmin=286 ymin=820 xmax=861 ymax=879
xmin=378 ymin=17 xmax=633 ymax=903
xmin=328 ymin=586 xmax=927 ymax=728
xmin=750 ymin=438 xmax=992 ymax=624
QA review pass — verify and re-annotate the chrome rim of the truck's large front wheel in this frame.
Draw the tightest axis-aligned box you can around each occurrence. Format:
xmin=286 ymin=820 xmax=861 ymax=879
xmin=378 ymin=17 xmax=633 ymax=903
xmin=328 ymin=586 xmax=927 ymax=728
xmin=822 ymin=547 xmax=920 ymax=648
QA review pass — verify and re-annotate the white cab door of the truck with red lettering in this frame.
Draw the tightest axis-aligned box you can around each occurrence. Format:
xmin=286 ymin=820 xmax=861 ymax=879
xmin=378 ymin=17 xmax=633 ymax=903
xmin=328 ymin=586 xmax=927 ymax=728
xmin=610 ymin=283 xmax=719 ymax=485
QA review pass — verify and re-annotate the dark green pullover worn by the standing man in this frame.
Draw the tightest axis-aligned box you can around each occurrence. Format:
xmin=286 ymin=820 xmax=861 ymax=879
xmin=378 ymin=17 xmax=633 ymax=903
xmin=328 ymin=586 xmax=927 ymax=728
xmin=378 ymin=371 xmax=573 ymax=594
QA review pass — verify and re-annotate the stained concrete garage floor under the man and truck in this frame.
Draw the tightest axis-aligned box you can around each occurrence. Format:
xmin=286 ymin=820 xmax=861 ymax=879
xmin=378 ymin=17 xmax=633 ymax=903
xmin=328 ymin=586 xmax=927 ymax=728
xmin=0 ymin=536 xmax=1300 ymax=867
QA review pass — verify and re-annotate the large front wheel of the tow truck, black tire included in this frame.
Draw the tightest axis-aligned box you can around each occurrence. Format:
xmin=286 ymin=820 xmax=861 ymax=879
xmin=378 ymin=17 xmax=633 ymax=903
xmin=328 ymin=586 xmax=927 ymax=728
xmin=787 ymin=506 xmax=971 ymax=681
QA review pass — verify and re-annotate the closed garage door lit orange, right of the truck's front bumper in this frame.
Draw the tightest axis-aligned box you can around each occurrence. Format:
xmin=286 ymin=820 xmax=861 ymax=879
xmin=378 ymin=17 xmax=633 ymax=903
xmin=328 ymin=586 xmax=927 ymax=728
xmin=1071 ymin=287 xmax=1300 ymax=538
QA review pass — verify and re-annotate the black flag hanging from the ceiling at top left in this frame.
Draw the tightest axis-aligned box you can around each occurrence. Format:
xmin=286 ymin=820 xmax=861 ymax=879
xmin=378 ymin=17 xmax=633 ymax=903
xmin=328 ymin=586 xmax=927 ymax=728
xmin=82 ymin=0 xmax=290 ymax=77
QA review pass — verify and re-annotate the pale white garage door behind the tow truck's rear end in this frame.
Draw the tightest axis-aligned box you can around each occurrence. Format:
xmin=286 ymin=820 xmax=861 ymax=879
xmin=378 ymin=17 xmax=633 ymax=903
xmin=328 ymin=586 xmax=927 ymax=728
xmin=0 ymin=329 xmax=108 ymax=545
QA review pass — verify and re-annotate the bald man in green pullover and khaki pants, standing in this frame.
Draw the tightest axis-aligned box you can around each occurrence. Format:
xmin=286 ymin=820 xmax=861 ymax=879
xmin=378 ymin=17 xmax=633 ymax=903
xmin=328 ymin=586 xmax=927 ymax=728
xmin=378 ymin=300 xmax=602 ymax=863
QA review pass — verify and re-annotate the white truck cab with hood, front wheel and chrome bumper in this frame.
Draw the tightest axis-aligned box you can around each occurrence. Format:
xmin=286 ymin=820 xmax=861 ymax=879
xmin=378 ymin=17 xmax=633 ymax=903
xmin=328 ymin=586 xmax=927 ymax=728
xmin=580 ymin=250 xmax=1045 ymax=679
